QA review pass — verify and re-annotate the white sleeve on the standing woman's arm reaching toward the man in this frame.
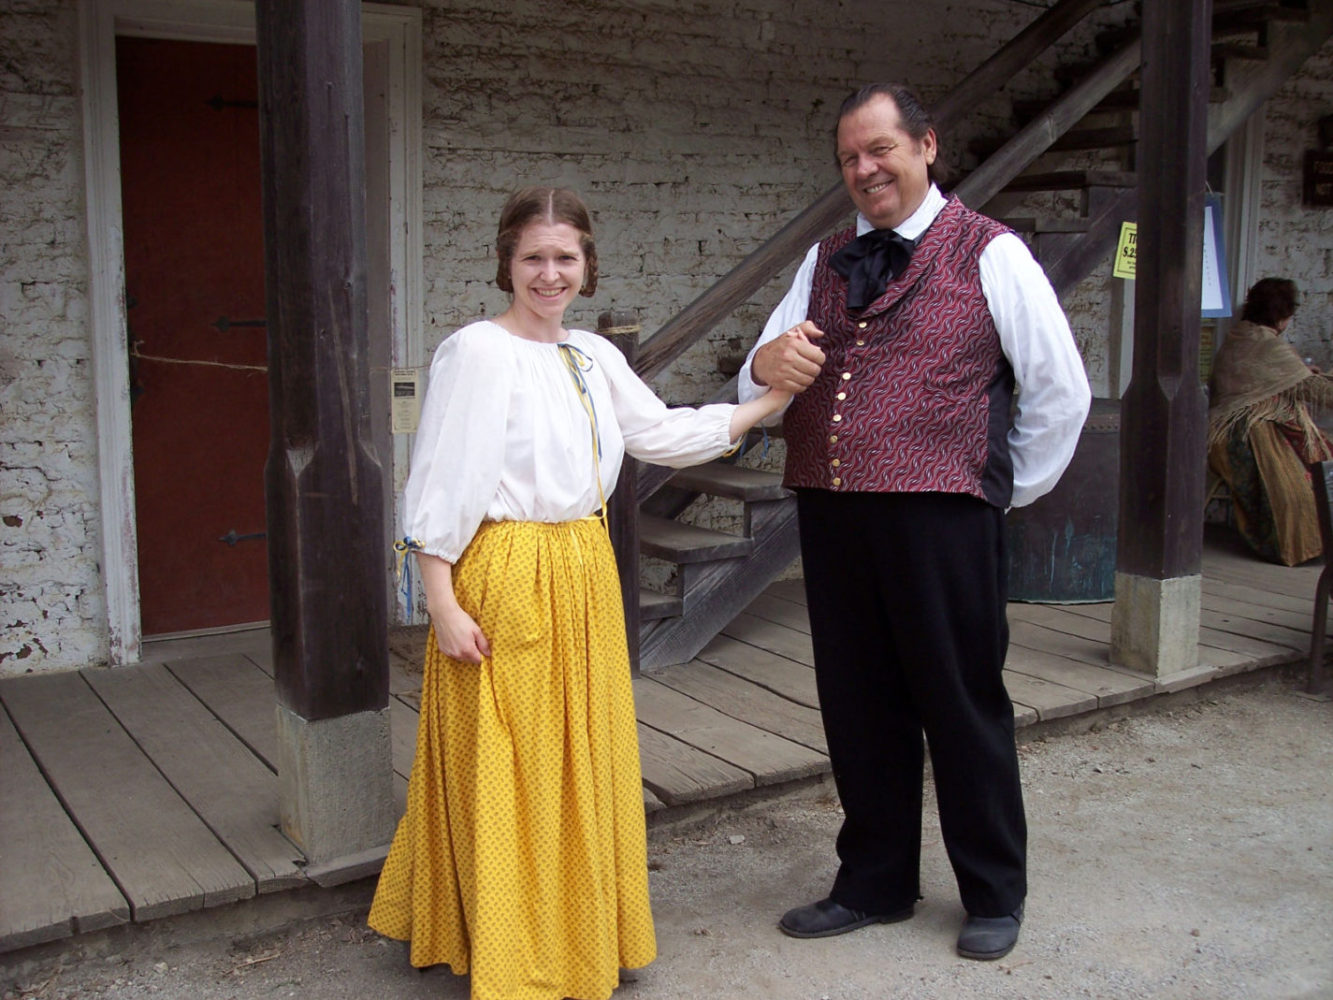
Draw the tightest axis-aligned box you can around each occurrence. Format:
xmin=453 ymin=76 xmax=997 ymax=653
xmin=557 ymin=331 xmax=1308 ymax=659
xmin=591 ymin=335 xmax=736 ymax=469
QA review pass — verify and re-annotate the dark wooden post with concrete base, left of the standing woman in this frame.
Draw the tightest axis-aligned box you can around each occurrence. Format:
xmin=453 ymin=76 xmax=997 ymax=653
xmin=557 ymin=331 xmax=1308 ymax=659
xmin=256 ymin=0 xmax=393 ymax=869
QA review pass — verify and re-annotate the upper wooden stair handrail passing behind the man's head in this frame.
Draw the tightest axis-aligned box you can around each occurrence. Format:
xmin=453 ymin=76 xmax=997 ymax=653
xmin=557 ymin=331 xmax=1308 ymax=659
xmin=636 ymin=0 xmax=1101 ymax=379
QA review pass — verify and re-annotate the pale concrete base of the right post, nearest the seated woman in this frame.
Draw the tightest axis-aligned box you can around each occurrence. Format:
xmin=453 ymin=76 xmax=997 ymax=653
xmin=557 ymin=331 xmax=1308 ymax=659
xmin=1110 ymin=573 xmax=1204 ymax=680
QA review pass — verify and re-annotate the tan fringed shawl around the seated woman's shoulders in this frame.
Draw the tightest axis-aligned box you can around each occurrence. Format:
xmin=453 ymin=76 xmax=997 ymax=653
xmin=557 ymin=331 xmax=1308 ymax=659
xmin=1208 ymin=320 xmax=1333 ymax=461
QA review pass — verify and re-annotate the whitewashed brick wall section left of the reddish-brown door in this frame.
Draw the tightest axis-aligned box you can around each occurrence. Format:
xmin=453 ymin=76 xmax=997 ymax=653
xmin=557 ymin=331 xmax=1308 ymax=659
xmin=0 ymin=0 xmax=107 ymax=673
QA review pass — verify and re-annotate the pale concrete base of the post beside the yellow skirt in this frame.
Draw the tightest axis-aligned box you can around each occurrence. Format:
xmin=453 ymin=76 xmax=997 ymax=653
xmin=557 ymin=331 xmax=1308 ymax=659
xmin=277 ymin=705 xmax=396 ymax=868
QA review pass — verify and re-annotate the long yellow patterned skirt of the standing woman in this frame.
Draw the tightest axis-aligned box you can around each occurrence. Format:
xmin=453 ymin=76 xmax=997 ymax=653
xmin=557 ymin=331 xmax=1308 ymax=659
xmin=369 ymin=519 xmax=657 ymax=1000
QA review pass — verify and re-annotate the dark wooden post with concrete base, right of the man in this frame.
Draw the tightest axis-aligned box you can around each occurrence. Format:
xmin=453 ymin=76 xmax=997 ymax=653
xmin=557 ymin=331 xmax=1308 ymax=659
xmin=1110 ymin=0 xmax=1213 ymax=677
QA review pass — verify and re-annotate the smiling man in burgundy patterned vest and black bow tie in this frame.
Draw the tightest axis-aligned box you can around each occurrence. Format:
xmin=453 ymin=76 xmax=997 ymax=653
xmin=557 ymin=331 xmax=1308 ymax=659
xmin=741 ymin=84 xmax=1090 ymax=959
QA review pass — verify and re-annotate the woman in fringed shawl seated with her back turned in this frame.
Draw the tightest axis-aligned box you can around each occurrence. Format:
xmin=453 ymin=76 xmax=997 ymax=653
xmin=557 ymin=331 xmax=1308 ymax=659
xmin=1208 ymin=277 xmax=1333 ymax=565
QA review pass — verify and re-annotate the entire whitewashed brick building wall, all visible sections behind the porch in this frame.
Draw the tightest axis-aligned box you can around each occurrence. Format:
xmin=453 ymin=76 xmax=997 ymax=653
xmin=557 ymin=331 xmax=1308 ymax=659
xmin=0 ymin=0 xmax=1333 ymax=673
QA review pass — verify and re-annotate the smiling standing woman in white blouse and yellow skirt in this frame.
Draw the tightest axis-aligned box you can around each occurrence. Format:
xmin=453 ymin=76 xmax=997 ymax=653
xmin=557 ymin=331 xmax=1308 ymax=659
xmin=369 ymin=188 xmax=788 ymax=1000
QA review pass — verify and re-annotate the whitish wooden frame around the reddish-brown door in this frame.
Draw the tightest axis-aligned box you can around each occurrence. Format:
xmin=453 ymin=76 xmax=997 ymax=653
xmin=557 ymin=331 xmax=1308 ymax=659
xmin=79 ymin=0 xmax=424 ymax=665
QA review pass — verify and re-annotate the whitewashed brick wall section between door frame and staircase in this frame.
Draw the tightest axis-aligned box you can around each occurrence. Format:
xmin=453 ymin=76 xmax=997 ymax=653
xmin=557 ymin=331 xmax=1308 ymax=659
xmin=407 ymin=0 xmax=1128 ymax=403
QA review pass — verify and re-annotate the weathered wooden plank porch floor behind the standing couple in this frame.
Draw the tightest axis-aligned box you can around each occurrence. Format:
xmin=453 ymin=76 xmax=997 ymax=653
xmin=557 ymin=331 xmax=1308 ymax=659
xmin=0 ymin=533 xmax=1321 ymax=952
